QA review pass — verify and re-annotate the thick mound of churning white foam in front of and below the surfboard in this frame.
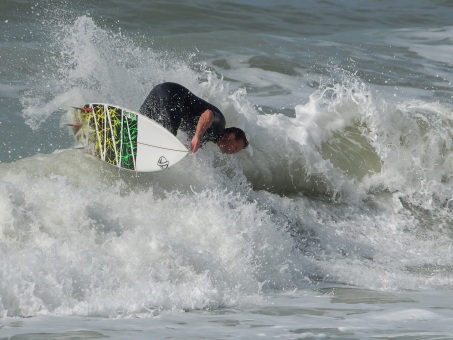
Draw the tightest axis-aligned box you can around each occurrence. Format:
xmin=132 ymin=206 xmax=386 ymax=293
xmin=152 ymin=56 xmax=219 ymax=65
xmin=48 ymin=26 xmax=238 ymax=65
xmin=0 ymin=151 xmax=308 ymax=316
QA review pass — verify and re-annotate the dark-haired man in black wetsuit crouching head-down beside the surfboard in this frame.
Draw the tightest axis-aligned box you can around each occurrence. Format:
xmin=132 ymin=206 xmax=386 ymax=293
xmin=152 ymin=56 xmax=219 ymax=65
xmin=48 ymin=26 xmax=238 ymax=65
xmin=139 ymin=83 xmax=248 ymax=154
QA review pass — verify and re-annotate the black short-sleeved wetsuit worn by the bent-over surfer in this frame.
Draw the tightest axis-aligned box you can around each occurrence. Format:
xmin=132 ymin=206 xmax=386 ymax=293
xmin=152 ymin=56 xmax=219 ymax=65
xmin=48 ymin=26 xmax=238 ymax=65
xmin=139 ymin=83 xmax=225 ymax=144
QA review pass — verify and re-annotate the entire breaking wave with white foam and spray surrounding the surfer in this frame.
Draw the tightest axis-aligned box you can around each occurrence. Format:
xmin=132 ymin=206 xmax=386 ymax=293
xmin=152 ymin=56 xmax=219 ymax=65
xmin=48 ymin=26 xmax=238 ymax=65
xmin=0 ymin=9 xmax=452 ymax=316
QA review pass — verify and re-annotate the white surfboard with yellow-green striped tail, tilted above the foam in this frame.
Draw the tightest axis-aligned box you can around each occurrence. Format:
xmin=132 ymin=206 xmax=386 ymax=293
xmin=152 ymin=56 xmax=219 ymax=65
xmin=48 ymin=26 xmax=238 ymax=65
xmin=67 ymin=103 xmax=188 ymax=172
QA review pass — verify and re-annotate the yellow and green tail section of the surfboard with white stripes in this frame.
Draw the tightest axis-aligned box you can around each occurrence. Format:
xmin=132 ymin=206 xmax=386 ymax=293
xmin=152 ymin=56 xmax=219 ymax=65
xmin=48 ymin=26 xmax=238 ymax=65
xmin=72 ymin=104 xmax=138 ymax=170
